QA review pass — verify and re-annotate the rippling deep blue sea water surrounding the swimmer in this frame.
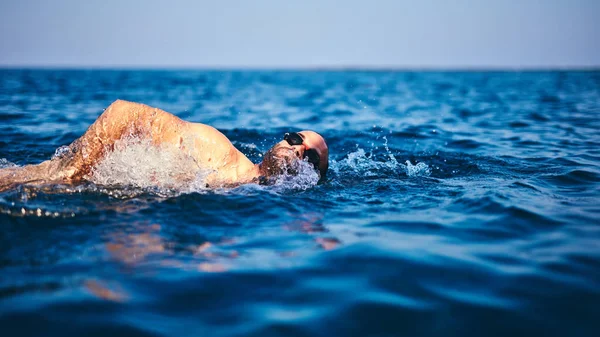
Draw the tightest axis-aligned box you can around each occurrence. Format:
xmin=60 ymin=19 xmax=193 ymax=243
xmin=0 ymin=69 xmax=600 ymax=336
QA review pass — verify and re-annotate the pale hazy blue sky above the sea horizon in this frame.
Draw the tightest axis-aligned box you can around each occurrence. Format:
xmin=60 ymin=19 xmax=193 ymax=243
xmin=0 ymin=0 xmax=600 ymax=68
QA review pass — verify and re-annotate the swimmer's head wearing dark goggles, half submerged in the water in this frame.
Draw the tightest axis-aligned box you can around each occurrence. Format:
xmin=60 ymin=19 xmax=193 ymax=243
xmin=260 ymin=131 xmax=329 ymax=178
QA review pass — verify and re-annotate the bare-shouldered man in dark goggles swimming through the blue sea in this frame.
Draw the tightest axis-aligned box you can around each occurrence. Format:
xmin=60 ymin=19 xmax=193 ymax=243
xmin=0 ymin=100 xmax=329 ymax=191
